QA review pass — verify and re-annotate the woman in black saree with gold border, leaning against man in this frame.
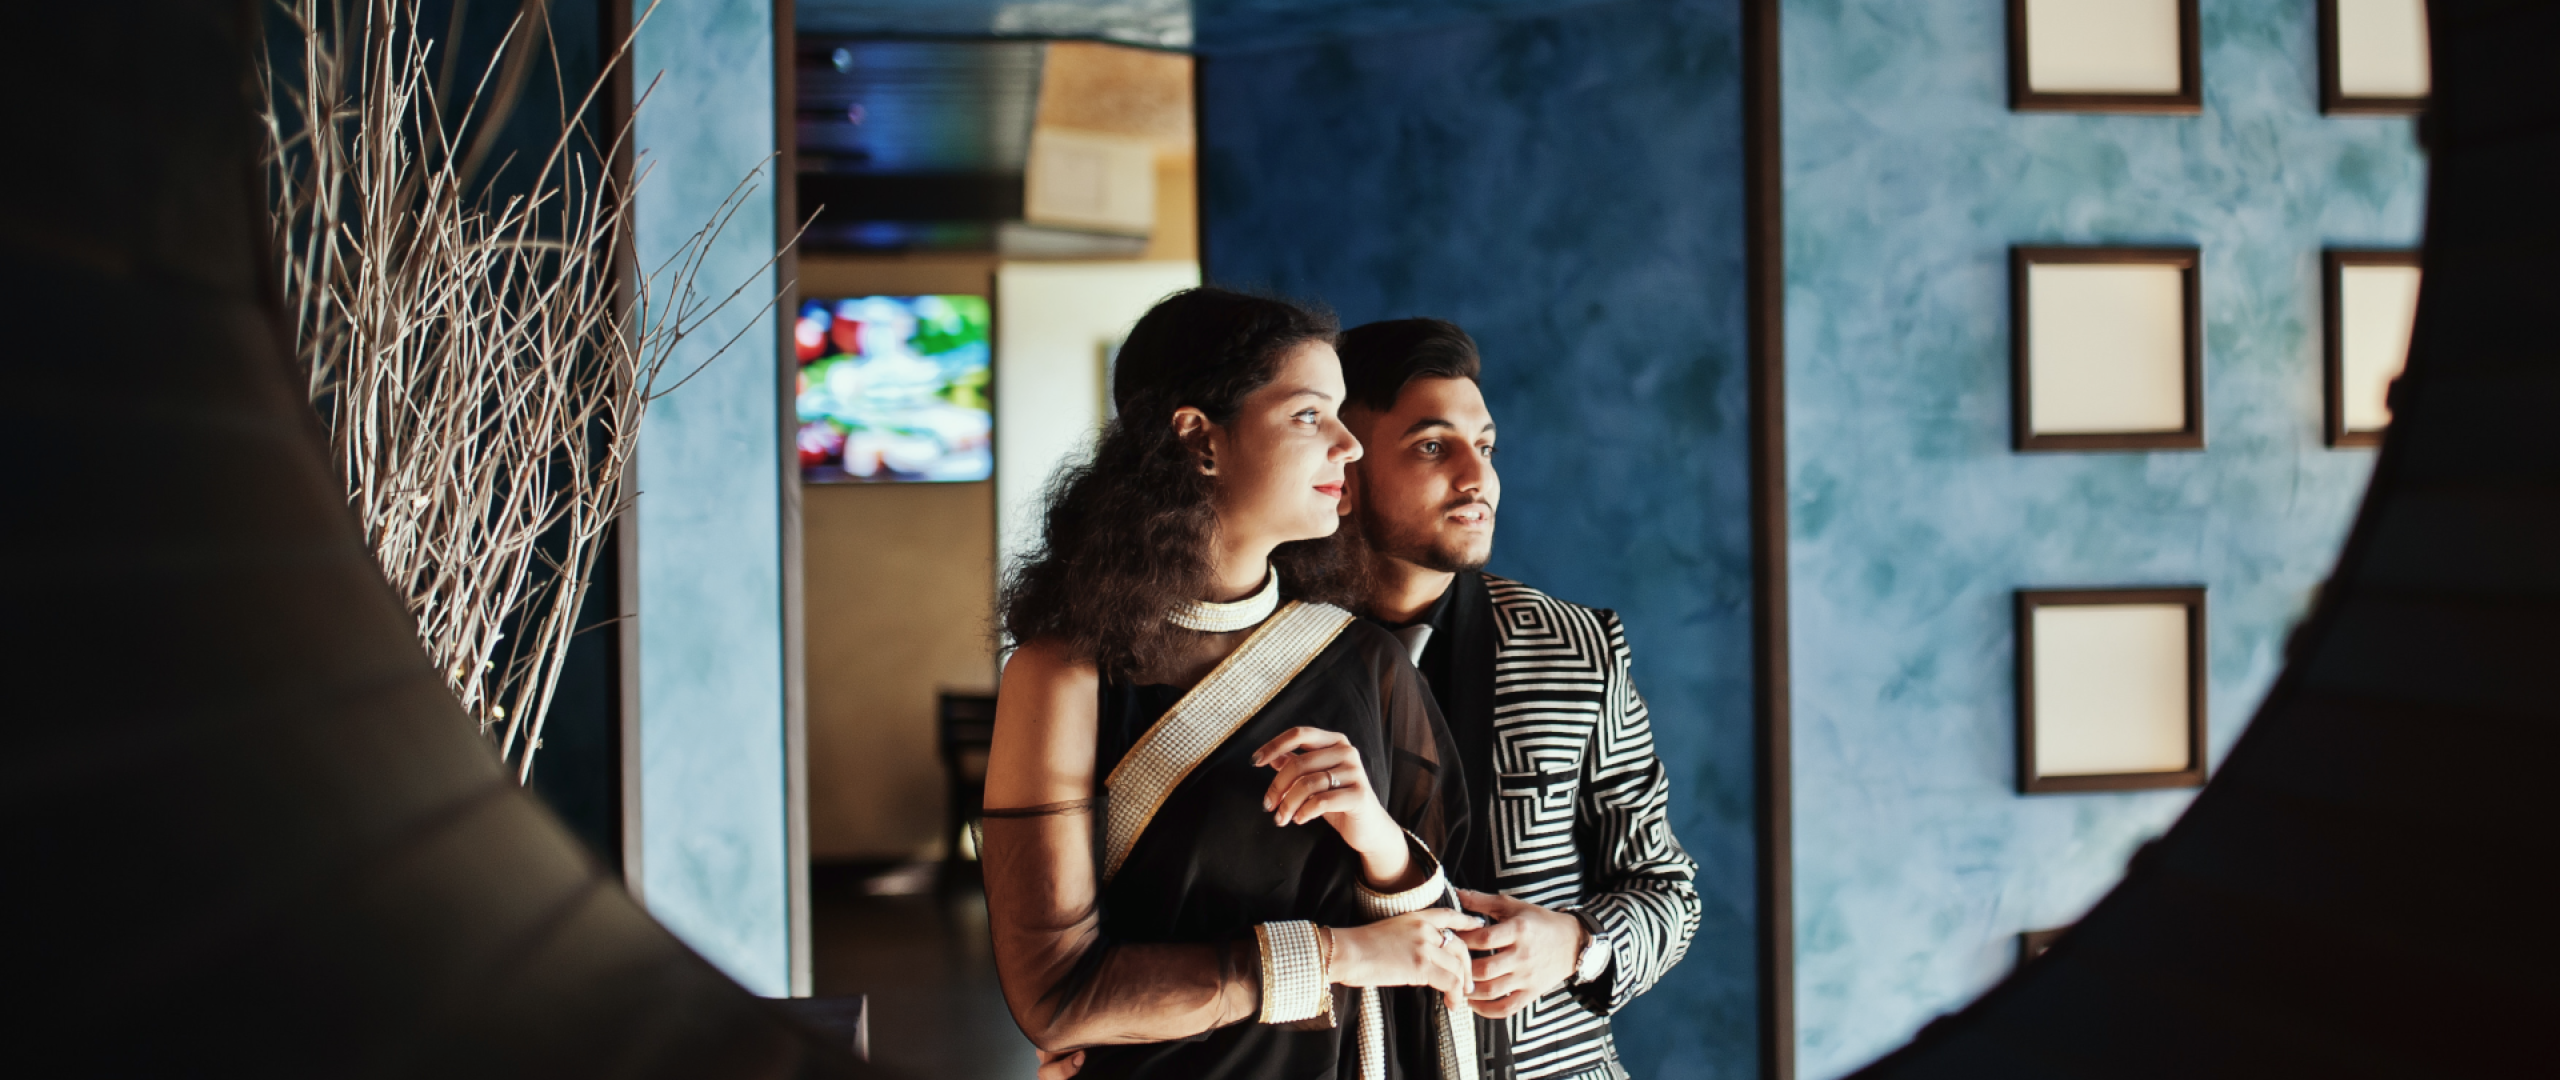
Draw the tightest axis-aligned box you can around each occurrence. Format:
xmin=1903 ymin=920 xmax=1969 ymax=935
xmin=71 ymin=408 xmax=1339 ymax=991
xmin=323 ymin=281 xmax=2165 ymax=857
xmin=983 ymin=289 xmax=1477 ymax=1080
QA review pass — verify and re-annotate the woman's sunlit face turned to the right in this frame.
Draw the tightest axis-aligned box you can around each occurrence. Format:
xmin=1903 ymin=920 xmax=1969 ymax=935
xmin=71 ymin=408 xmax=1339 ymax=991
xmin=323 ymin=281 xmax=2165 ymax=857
xmin=1178 ymin=340 xmax=1359 ymax=545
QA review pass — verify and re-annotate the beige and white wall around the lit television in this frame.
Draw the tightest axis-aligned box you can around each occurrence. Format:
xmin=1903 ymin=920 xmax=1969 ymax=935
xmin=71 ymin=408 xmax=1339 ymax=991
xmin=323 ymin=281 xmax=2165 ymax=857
xmin=801 ymin=256 xmax=1201 ymax=860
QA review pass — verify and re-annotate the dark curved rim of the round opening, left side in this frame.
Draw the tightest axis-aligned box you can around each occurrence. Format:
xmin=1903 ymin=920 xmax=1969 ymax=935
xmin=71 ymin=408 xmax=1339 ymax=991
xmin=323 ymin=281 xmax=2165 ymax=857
xmin=0 ymin=0 xmax=883 ymax=1077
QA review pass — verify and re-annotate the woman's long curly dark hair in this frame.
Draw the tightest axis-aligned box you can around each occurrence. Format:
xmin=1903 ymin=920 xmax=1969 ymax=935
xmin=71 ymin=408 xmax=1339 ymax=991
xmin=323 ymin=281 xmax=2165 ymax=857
xmin=996 ymin=287 xmax=1362 ymax=678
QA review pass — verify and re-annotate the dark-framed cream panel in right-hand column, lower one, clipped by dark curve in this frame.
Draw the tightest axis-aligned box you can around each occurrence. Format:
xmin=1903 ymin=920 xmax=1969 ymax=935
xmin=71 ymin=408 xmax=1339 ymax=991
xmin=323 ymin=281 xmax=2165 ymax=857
xmin=2319 ymin=251 xmax=2419 ymax=445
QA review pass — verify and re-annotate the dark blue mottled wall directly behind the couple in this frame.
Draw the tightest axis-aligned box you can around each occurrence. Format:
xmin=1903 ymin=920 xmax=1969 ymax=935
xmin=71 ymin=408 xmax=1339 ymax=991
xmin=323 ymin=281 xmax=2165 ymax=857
xmin=1201 ymin=3 xmax=1756 ymax=1077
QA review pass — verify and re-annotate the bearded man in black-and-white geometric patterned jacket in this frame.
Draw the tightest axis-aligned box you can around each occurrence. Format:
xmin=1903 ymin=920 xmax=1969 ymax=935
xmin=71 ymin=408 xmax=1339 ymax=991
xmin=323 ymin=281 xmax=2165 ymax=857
xmin=1339 ymin=320 xmax=1697 ymax=1080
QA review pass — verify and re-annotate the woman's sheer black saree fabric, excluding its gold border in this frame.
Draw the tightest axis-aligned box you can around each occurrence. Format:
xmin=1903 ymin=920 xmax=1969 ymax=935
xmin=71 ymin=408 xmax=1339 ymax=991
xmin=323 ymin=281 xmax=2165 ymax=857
xmin=986 ymin=609 xmax=1467 ymax=1080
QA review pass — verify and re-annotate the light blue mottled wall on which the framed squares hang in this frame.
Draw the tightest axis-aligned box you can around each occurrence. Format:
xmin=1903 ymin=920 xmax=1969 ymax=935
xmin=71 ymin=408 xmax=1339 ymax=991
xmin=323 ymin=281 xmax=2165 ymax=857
xmin=1782 ymin=0 xmax=2422 ymax=1077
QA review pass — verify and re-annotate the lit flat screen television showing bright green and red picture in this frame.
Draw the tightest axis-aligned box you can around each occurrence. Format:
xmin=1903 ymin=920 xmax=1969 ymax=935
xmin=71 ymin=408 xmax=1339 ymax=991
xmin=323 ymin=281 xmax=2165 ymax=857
xmin=794 ymin=297 xmax=996 ymax=484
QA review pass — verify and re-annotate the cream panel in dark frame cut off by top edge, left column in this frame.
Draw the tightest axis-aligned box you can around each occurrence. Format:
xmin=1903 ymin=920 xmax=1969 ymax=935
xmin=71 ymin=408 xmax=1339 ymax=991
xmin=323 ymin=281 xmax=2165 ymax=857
xmin=2010 ymin=0 xmax=2204 ymax=113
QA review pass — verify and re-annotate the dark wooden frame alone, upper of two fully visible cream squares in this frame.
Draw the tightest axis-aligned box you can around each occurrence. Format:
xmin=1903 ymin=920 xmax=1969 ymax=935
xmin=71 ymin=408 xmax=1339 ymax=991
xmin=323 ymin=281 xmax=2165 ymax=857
xmin=2010 ymin=246 xmax=2204 ymax=453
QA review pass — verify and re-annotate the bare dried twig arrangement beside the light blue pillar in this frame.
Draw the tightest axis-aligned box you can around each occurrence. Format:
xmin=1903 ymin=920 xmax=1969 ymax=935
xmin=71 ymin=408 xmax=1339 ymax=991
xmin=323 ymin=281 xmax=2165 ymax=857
xmin=261 ymin=0 xmax=771 ymax=783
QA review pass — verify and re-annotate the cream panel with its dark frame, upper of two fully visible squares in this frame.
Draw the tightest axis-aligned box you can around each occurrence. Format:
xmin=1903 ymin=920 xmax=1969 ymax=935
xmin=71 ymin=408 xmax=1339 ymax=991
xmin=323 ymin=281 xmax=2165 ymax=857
xmin=2010 ymin=248 xmax=2204 ymax=450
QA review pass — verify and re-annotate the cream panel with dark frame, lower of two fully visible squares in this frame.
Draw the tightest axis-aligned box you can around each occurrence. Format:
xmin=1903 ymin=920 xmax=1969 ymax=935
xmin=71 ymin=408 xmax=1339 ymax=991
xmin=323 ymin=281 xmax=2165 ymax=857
xmin=2017 ymin=586 xmax=2204 ymax=796
